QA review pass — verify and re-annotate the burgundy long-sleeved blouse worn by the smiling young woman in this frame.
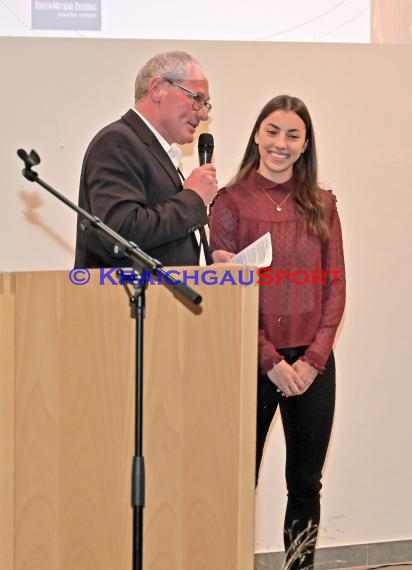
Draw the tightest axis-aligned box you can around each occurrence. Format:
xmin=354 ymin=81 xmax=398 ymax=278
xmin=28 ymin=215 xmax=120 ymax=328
xmin=210 ymin=172 xmax=345 ymax=374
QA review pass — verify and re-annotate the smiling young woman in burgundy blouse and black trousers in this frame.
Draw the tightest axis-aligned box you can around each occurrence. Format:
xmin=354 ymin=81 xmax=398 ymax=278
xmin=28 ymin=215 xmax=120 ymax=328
xmin=210 ymin=95 xmax=345 ymax=570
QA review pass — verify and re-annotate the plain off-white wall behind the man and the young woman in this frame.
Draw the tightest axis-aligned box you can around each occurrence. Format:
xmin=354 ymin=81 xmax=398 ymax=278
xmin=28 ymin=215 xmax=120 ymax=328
xmin=0 ymin=38 xmax=412 ymax=551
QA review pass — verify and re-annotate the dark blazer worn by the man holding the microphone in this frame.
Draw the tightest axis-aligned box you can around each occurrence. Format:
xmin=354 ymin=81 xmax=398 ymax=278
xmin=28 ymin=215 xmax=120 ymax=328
xmin=75 ymin=109 xmax=207 ymax=267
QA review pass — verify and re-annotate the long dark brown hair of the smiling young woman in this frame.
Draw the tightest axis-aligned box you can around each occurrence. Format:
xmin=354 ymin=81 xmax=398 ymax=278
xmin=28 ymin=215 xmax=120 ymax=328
xmin=229 ymin=95 xmax=330 ymax=241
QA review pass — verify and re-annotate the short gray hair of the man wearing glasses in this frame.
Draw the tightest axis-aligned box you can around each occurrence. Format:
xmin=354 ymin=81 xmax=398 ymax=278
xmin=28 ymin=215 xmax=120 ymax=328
xmin=135 ymin=51 xmax=200 ymax=101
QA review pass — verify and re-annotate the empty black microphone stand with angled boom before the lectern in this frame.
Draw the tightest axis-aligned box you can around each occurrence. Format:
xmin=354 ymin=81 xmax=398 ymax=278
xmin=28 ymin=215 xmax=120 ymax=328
xmin=17 ymin=149 xmax=202 ymax=570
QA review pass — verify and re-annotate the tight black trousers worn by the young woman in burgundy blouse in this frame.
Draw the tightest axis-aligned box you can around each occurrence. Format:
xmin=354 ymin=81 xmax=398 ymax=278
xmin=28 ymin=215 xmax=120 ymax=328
xmin=256 ymin=347 xmax=335 ymax=570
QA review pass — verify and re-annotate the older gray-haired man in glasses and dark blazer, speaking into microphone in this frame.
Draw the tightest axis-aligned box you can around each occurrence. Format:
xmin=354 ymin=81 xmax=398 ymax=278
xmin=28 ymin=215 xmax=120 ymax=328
xmin=75 ymin=51 xmax=217 ymax=267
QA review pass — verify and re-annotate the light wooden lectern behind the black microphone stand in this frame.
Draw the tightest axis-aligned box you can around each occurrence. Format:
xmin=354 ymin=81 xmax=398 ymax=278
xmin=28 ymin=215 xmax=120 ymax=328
xmin=0 ymin=266 xmax=258 ymax=570
